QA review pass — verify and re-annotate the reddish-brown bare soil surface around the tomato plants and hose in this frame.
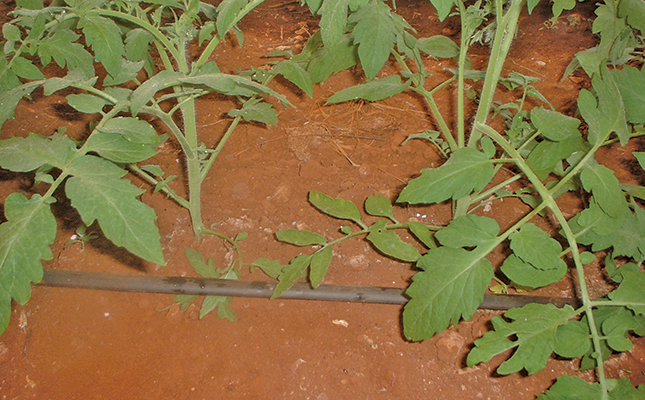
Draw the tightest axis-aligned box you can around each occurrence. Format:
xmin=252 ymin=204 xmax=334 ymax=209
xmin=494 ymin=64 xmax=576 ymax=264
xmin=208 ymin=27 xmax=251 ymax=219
xmin=0 ymin=0 xmax=645 ymax=400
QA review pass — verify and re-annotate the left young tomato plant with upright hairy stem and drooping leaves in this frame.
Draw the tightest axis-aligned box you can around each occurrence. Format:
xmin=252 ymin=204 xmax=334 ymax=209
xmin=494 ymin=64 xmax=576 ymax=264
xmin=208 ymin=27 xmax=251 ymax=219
xmin=0 ymin=0 xmax=311 ymax=331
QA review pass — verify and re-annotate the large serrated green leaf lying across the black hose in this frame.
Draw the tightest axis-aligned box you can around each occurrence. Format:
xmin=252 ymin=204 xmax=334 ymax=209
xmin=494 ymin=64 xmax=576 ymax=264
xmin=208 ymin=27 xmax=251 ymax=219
xmin=403 ymin=247 xmax=493 ymax=340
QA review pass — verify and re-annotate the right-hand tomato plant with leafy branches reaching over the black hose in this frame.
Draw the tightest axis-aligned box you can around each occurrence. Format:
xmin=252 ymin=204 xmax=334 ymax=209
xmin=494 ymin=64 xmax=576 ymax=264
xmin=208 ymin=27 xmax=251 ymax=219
xmin=253 ymin=0 xmax=645 ymax=399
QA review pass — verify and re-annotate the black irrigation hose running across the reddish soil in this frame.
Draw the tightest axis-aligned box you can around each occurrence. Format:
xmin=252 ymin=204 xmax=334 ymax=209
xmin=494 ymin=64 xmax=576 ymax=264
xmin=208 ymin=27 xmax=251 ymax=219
xmin=40 ymin=269 xmax=580 ymax=310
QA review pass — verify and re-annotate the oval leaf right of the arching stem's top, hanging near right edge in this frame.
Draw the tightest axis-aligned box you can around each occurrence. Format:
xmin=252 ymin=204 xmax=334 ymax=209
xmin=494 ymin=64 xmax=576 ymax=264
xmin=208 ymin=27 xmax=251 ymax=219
xmin=580 ymin=165 xmax=629 ymax=218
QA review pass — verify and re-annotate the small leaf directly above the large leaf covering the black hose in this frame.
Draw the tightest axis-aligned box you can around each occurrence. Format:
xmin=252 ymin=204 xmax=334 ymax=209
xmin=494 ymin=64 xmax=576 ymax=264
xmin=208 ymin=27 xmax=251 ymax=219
xmin=435 ymin=214 xmax=499 ymax=248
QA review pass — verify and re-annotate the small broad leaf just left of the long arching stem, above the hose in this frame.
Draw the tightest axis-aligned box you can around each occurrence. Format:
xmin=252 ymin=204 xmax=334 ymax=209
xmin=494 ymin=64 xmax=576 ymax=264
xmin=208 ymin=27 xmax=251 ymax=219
xmin=510 ymin=224 xmax=566 ymax=270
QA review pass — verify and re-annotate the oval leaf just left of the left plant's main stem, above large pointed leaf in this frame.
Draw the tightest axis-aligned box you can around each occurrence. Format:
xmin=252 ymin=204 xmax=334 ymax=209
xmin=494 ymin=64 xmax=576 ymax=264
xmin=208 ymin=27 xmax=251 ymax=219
xmin=85 ymin=132 xmax=157 ymax=164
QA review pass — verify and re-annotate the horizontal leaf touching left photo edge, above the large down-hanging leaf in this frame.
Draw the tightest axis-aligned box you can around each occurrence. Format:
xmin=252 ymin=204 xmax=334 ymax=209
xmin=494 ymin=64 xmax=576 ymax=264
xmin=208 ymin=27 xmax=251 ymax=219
xmin=0 ymin=133 xmax=76 ymax=172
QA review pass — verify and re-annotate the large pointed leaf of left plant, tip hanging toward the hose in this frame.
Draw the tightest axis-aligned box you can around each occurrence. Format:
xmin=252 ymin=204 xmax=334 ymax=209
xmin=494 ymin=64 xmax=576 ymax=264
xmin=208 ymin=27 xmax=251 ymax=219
xmin=65 ymin=155 xmax=165 ymax=265
